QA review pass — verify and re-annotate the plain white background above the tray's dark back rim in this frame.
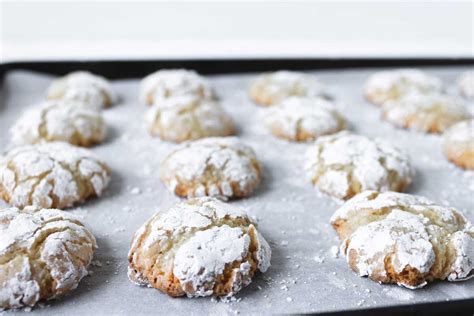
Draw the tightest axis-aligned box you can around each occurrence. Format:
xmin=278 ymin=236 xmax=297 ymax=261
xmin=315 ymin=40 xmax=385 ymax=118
xmin=1 ymin=0 xmax=474 ymax=61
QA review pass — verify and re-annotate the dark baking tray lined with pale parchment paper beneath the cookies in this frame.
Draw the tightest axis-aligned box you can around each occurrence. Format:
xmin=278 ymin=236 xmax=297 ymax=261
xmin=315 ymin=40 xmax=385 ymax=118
xmin=0 ymin=59 xmax=474 ymax=315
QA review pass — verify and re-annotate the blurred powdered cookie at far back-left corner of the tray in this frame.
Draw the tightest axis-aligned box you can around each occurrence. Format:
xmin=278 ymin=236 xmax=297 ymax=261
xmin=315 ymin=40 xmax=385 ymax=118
xmin=47 ymin=71 xmax=117 ymax=108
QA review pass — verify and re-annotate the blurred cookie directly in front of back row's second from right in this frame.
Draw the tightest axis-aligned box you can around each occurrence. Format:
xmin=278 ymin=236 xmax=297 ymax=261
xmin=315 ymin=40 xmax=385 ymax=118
xmin=382 ymin=94 xmax=471 ymax=133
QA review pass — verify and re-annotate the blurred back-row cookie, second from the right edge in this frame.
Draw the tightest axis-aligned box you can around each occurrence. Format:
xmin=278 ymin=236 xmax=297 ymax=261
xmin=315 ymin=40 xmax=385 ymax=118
xmin=364 ymin=69 xmax=442 ymax=105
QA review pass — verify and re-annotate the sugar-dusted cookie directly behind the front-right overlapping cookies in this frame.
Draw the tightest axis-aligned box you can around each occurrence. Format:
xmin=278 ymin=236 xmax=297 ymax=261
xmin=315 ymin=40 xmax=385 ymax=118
xmin=305 ymin=131 xmax=413 ymax=200
